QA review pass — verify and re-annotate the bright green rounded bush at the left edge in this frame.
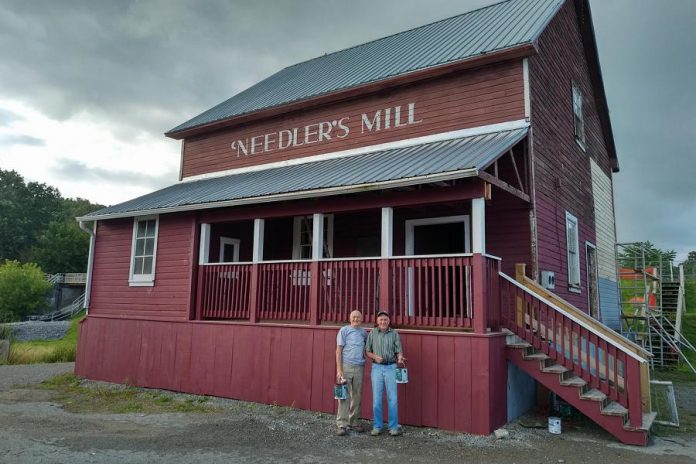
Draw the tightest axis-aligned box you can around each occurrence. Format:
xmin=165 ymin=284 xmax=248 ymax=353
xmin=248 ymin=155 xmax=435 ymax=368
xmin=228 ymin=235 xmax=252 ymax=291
xmin=0 ymin=260 xmax=51 ymax=322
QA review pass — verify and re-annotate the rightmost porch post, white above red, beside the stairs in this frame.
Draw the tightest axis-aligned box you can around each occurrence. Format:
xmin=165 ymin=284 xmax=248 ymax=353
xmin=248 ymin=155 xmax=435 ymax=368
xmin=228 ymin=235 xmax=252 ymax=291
xmin=471 ymin=198 xmax=488 ymax=333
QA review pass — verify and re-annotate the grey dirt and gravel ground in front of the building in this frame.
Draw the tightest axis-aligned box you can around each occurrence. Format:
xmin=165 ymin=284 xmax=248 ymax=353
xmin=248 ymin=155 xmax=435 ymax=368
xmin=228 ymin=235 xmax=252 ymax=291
xmin=0 ymin=363 xmax=696 ymax=464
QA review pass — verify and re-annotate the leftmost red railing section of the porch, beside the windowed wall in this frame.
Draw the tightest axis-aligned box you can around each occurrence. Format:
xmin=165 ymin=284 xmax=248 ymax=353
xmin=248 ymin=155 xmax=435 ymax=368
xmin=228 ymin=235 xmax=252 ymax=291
xmin=198 ymin=264 xmax=251 ymax=319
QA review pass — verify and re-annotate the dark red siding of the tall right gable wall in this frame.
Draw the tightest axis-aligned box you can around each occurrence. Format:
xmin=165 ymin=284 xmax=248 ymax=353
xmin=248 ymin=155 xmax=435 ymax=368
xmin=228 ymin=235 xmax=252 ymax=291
xmin=529 ymin=2 xmax=611 ymax=309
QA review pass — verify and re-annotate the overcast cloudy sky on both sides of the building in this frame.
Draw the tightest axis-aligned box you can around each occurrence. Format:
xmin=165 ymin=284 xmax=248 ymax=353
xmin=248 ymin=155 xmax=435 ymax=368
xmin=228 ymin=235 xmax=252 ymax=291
xmin=0 ymin=0 xmax=696 ymax=258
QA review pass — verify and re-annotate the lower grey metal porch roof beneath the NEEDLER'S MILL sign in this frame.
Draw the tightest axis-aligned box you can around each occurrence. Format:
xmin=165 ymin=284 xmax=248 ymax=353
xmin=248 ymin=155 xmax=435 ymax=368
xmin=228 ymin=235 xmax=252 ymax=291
xmin=77 ymin=126 xmax=528 ymax=221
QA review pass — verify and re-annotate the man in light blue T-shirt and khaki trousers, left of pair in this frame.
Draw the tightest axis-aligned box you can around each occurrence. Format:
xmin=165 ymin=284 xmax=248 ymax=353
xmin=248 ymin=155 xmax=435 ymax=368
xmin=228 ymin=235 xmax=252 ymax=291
xmin=336 ymin=311 xmax=367 ymax=436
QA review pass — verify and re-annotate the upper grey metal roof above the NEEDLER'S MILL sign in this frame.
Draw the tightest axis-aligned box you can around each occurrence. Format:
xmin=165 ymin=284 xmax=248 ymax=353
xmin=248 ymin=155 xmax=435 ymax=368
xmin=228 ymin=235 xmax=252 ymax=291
xmin=168 ymin=0 xmax=564 ymax=134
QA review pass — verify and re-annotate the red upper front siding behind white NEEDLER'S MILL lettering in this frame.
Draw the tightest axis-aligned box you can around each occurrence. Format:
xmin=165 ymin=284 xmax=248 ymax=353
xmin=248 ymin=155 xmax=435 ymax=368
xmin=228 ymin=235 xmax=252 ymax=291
xmin=182 ymin=60 xmax=524 ymax=177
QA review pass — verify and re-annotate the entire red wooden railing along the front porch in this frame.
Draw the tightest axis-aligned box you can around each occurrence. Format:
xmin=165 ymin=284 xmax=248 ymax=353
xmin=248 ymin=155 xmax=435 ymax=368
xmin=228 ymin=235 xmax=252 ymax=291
xmin=196 ymin=254 xmax=499 ymax=328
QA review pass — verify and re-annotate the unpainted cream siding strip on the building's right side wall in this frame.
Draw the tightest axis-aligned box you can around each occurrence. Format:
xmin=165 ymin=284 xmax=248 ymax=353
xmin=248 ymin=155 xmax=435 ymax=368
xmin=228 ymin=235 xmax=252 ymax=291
xmin=590 ymin=160 xmax=616 ymax=282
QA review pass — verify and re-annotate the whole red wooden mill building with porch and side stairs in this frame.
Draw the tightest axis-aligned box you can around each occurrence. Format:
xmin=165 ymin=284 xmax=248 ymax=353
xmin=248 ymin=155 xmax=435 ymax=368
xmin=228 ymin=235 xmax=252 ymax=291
xmin=76 ymin=0 xmax=652 ymax=444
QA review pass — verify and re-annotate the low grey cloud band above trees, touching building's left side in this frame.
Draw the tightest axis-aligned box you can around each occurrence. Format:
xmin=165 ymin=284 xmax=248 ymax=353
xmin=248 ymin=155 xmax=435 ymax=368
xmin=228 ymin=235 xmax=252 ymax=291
xmin=54 ymin=159 xmax=177 ymax=190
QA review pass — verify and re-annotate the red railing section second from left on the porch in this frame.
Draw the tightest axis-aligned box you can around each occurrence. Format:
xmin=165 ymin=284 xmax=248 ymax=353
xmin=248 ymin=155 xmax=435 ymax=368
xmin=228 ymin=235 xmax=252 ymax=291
xmin=257 ymin=261 xmax=312 ymax=321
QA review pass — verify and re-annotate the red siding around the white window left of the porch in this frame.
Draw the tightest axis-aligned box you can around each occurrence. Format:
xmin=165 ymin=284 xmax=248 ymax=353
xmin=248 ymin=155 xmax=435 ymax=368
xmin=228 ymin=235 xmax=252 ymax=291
xmin=89 ymin=214 xmax=194 ymax=320
